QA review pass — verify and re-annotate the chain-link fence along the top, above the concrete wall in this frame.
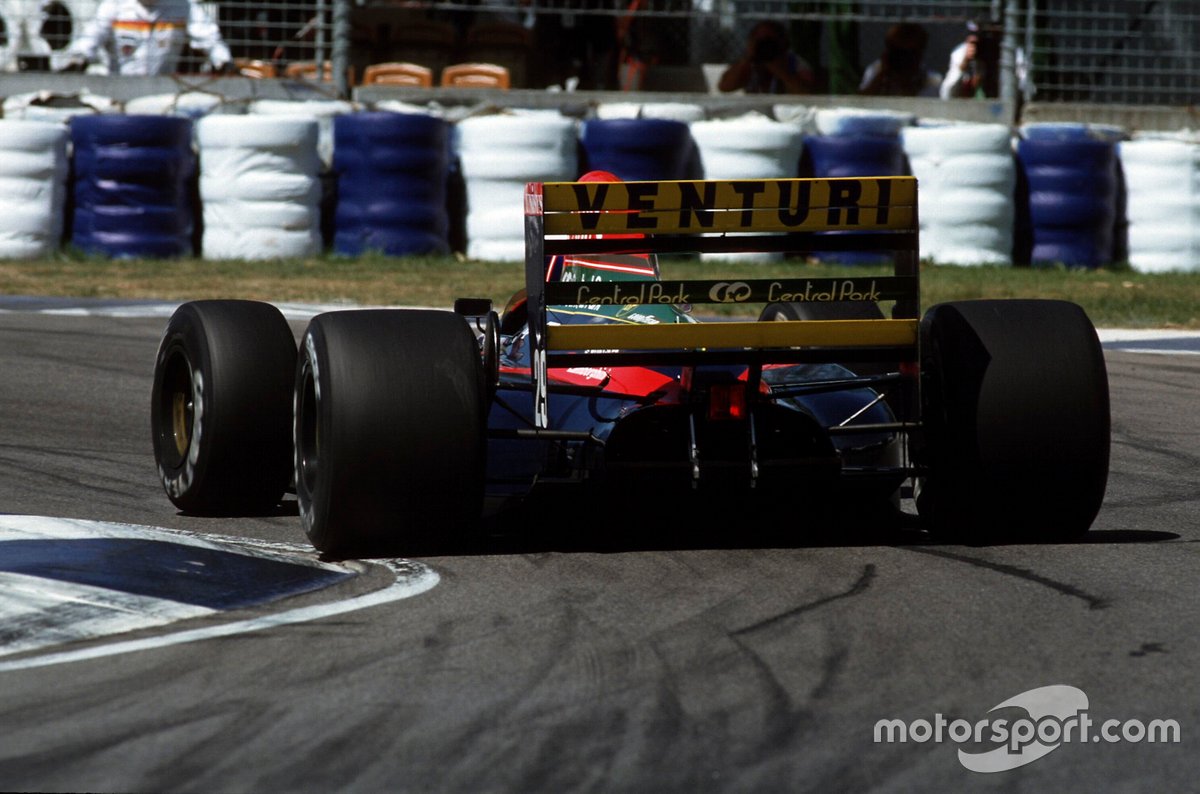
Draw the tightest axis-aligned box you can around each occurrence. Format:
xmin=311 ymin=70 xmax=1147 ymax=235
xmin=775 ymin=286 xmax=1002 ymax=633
xmin=0 ymin=0 xmax=1200 ymax=106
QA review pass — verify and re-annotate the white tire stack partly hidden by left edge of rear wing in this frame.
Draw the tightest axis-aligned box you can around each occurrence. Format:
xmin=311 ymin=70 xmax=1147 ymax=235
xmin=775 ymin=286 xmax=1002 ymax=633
xmin=455 ymin=114 xmax=576 ymax=261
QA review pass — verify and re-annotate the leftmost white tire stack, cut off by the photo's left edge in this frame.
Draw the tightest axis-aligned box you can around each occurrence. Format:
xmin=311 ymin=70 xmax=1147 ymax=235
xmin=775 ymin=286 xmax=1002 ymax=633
xmin=0 ymin=119 xmax=70 ymax=259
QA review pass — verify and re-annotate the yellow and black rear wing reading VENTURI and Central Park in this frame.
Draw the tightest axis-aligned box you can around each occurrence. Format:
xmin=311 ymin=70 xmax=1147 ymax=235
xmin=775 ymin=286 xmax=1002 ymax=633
xmin=524 ymin=176 xmax=919 ymax=428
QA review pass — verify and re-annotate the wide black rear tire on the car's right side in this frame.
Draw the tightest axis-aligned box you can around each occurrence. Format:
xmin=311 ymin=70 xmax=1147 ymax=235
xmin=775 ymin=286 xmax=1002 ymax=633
xmin=917 ymin=300 xmax=1110 ymax=543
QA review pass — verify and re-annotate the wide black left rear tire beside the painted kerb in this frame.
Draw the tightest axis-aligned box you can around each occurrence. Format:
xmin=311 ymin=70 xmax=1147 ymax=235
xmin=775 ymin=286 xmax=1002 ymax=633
xmin=294 ymin=309 xmax=486 ymax=558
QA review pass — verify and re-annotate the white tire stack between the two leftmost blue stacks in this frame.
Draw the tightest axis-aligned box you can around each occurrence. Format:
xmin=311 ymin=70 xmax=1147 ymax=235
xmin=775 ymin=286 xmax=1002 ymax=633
xmin=196 ymin=115 xmax=322 ymax=259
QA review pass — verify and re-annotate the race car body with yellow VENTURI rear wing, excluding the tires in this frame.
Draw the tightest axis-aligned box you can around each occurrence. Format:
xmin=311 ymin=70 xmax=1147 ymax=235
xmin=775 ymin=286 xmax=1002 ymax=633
xmin=464 ymin=178 xmax=918 ymax=515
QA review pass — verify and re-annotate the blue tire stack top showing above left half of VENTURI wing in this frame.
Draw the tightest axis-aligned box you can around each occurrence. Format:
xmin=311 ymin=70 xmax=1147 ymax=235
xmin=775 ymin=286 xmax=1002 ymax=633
xmin=581 ymin=119 xmax=701 ymax=182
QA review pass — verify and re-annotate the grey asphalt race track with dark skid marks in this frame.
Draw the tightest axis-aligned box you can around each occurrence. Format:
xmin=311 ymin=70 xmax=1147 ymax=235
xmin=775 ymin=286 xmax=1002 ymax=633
xmin=0 ymin=303 xmax=1200 ymax=792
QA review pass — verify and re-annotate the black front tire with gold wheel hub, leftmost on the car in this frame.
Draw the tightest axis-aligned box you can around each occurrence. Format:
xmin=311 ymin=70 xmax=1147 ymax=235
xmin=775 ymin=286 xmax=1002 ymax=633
xmin=150 ymin=301 xmax=296 ymax=515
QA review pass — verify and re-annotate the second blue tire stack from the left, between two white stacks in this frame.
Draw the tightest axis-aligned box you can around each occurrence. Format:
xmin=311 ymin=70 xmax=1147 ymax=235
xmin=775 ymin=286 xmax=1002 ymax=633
xmin=334 ymin=113 xmax=450 ymax=255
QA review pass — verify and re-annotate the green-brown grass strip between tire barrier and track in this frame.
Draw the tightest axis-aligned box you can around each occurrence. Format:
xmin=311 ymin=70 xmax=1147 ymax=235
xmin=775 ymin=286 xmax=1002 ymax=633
xmin=0 ymin=254 xmax=1200 ymax=329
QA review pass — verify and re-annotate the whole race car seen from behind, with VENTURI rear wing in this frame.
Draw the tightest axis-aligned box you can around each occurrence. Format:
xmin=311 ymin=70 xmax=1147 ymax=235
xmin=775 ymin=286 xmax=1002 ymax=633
xmin=152 ymin=173 xmax=1110 ymax=557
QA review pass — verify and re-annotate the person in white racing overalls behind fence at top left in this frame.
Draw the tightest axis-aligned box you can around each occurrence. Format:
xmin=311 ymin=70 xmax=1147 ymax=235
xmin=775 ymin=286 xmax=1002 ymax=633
xmin=62 ymin=0 xmax=233 ymax=74
